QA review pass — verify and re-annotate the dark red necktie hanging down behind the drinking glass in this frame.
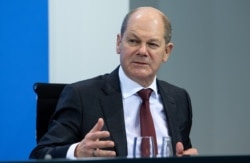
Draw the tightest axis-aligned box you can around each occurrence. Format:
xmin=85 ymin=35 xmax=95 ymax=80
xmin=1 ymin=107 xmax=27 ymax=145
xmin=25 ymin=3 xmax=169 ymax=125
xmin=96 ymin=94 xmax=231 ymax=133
xmin=137 ymin=89 xmax=158 ymax=157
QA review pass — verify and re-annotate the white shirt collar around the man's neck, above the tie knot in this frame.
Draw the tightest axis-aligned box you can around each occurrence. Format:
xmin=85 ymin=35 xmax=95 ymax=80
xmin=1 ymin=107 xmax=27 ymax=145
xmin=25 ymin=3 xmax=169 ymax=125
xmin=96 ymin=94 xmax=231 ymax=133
xmin=119 ymin=66 xmax=158 ymax=98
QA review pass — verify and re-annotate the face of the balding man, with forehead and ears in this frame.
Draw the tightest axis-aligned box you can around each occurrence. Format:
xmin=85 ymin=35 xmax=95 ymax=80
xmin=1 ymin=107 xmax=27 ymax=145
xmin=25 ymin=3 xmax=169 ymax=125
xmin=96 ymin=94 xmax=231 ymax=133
xmin=117 ymin=10 xmax=173 ymax=84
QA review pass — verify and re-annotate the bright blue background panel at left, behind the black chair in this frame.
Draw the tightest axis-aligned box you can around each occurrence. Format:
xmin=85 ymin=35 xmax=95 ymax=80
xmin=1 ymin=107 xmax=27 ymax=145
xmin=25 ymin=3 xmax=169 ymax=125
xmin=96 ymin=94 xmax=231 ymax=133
xmin=0 ymin=0 xmax=48 ymax=161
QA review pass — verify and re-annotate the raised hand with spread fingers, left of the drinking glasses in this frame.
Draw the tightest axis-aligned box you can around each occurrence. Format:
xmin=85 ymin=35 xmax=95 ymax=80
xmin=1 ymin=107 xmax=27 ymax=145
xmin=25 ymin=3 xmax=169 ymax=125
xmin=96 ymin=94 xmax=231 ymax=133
xmin=75 ymin=118 xmax=116 ymax=157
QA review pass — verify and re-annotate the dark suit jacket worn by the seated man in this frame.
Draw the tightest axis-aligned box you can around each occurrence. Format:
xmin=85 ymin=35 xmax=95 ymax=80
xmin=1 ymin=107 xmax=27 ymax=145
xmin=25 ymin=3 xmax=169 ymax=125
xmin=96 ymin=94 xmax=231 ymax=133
xmin=30 ymin=65 xmax=192 ymax=158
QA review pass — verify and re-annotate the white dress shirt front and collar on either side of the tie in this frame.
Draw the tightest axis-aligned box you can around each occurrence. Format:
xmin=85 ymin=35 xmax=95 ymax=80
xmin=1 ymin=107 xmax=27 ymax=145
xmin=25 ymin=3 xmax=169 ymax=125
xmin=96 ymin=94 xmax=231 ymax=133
xmin=119 ymin=67 xmax=169 ymax=157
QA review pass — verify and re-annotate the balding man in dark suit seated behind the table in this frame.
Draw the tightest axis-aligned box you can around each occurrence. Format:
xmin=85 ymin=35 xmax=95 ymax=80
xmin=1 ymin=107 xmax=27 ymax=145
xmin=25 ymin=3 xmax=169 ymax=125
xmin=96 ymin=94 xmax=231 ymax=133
xmin=30 ymin=7 xmax=198 ymax=159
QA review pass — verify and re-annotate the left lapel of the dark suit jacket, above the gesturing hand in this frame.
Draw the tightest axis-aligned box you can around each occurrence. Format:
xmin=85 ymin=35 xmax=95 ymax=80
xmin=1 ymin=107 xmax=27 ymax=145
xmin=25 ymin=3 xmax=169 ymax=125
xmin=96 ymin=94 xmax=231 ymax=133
xmin=101 ymin=69 xmax=127 ymax=156
